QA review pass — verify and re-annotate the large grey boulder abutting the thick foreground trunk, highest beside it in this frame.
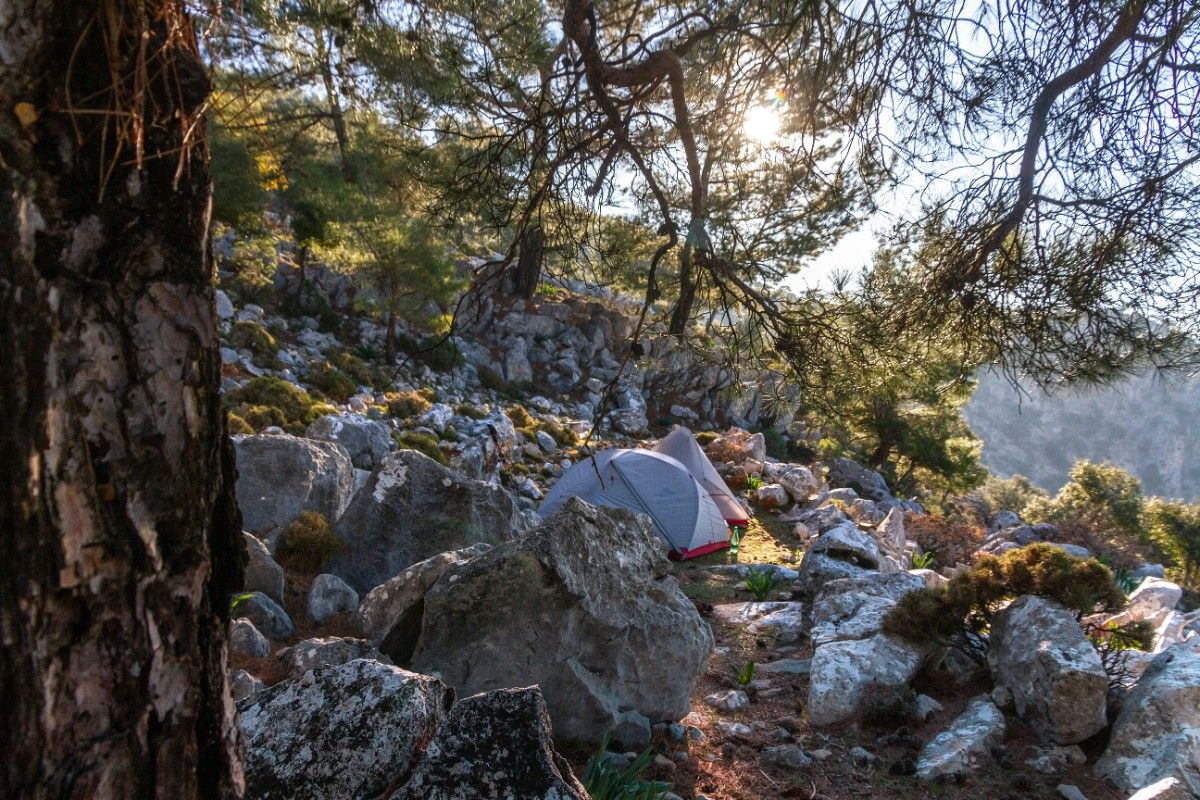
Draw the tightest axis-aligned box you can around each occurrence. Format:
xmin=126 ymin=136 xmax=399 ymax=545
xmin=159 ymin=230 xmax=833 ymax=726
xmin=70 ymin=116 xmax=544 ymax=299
xmin=234 ymin=435 xmax=354 ymax=534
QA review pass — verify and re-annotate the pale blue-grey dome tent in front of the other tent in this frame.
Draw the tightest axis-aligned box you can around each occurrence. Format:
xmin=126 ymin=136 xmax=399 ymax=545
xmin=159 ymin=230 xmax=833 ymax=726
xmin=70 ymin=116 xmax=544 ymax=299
xmin=538 ymin=450 xmax=730 ymax=559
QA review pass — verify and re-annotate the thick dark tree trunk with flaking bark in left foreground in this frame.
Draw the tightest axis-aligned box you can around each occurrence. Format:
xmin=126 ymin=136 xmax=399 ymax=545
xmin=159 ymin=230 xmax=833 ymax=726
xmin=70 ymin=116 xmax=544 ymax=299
xmin=0 ymin=0 xmax=245 ymax=800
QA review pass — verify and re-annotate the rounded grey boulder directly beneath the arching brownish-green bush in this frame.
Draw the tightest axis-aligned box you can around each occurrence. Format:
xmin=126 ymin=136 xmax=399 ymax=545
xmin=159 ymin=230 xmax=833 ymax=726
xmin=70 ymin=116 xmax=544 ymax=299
xmin=988 ymin=596 xmax=1109 ymax=745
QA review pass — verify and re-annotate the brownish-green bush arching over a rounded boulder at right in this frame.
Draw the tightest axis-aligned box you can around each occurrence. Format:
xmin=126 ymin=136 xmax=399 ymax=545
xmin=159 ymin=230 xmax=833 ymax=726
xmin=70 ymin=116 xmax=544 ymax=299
xmin=883 ymin=542 xmax=1126 ymax=666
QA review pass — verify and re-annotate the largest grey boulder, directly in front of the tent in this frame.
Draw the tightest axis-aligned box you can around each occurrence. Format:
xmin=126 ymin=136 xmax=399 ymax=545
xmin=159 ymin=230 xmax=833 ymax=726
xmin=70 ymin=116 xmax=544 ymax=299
xmin=412 ymin=498 xmax=713 ymax=744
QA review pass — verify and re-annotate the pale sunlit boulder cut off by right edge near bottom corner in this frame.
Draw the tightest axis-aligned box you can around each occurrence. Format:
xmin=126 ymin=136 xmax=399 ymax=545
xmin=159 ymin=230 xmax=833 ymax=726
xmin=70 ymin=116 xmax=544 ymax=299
xmin=1096 ymin=644 xmax=1200 ymax=798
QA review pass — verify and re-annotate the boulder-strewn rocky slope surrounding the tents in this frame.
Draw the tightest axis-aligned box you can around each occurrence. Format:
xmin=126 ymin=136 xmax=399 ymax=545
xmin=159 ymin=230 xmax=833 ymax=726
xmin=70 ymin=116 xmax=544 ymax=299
xmin=218 ymin=253 xmax=1200 ymax=800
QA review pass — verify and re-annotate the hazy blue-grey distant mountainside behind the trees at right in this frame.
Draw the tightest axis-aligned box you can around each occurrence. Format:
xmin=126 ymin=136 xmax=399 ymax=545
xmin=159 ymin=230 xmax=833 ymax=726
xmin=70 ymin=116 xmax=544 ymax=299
xmin=966 ymin=373 xmax=1200 ymax=500
